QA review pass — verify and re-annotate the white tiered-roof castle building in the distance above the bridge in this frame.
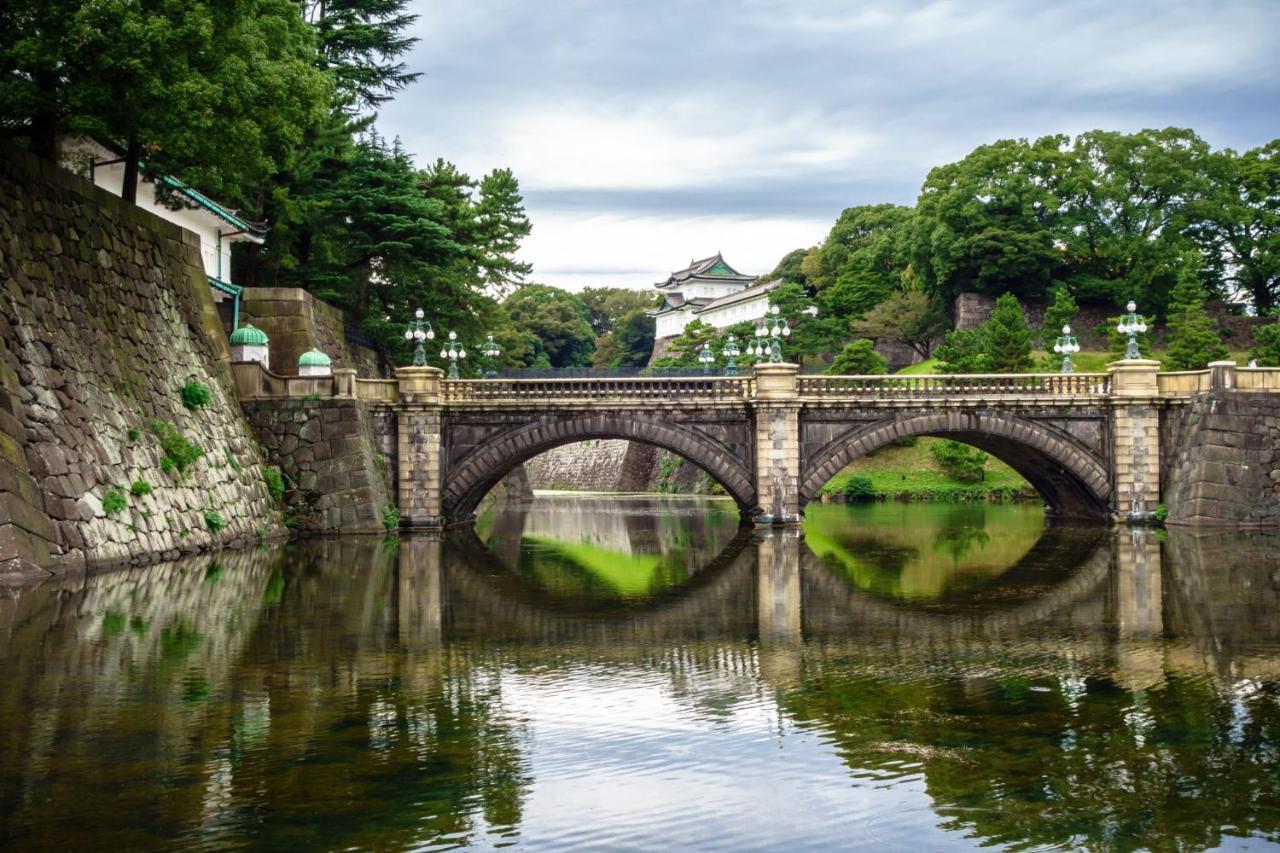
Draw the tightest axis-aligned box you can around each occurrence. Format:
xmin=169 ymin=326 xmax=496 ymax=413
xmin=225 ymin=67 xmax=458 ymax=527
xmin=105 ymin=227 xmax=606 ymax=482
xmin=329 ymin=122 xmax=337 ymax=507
xmin=650 ymin=252 xmax=782 ymax=338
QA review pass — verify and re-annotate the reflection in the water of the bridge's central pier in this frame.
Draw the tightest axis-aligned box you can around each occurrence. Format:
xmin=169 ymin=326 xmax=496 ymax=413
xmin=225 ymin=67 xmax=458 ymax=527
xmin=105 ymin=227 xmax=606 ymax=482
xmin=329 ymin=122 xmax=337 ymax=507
xmin=755 ymin=529 xmax=804 ymax=688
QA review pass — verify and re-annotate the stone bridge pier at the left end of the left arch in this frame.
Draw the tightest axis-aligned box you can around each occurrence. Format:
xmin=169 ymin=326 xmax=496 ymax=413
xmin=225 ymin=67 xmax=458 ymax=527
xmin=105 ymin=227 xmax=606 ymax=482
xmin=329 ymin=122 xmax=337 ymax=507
xmin=396 ymin=368 xmax=444 ymax=528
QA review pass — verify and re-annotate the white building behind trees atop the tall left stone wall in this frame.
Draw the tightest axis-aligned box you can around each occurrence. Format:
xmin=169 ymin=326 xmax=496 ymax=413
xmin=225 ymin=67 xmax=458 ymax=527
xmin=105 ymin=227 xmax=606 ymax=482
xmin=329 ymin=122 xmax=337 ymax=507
xmin=59 ymin=137 xmax=266 ymax=329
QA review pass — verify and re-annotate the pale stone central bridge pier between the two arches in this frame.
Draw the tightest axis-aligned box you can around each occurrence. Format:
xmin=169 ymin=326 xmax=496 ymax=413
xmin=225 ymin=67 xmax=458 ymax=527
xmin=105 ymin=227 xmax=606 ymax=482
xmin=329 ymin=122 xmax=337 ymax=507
xmin=751 ymin=364 xmax=800 ymax=525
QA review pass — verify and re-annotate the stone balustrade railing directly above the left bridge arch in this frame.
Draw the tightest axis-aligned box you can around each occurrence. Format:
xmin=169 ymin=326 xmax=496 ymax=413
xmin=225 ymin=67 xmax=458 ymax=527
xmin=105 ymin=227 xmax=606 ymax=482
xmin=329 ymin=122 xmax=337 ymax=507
xmin=443 ymin=377 xmax=753 ymax=403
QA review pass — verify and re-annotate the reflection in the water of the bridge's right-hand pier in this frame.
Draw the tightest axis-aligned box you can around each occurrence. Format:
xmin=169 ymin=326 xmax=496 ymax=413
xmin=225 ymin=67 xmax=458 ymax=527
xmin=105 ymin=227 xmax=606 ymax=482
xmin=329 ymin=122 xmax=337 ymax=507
xmin=1115 ymin=526 xmax=1165 ymax=688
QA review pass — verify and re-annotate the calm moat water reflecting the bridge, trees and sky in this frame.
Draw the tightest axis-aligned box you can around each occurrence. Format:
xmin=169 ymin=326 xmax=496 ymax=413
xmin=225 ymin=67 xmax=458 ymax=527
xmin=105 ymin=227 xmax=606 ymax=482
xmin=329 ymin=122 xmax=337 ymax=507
xmin=0 ymin=496 xmax=1280 ymax=850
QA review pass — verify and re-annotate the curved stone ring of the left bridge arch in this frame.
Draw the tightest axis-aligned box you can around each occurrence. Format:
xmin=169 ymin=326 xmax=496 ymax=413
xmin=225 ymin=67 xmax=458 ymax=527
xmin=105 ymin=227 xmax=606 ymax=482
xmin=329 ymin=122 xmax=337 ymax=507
xmin=442 ymin=411 xmax=756 ymax=521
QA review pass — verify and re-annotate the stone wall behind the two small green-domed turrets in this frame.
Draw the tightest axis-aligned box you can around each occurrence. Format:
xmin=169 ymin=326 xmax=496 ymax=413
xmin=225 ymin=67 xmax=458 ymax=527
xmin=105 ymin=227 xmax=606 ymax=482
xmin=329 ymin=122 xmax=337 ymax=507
xmin=241 ymin=287 xmax=385 ymax=379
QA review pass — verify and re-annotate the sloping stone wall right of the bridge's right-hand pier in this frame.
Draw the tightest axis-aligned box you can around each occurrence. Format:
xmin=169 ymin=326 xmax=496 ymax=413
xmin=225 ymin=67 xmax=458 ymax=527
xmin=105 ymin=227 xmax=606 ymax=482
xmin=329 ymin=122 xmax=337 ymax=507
xmin=1165 ymin=391 xmax=1280 ymax=524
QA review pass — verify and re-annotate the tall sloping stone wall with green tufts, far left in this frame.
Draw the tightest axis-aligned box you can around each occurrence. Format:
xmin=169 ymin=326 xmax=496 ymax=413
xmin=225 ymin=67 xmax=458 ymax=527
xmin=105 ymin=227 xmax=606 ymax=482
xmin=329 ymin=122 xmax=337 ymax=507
xmin=0 ymin=145 xmax=279 ymax=579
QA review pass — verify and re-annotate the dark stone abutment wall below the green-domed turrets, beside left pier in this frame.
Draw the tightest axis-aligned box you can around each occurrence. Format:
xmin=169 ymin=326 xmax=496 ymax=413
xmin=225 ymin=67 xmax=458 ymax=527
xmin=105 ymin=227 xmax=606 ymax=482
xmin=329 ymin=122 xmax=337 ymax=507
xmin=244 ymin=398 xmax=396 ymax=533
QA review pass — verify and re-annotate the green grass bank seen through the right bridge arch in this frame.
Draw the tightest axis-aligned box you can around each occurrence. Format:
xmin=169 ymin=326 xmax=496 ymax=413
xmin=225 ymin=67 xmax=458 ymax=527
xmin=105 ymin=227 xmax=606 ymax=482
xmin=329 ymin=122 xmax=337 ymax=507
xmin=819 ymin=438 xmax=1042 ymax=502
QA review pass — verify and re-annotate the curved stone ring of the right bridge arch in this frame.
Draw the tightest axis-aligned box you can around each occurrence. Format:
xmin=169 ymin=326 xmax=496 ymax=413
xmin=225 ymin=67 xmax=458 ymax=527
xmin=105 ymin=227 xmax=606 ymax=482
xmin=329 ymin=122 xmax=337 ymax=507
xmin=799 ymin=411 xmax=1111 ymax=517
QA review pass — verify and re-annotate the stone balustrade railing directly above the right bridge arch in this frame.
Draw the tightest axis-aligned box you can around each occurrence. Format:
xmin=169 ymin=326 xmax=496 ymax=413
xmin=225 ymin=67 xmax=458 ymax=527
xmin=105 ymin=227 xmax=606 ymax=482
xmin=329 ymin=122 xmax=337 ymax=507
xmin=799 ymin=373 xmax=1111 ymax=400
